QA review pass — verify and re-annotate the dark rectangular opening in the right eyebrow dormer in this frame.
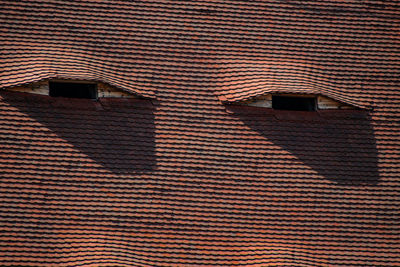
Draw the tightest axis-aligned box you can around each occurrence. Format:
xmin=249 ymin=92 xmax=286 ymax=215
xmin=272 ymin=96 xmax=316 ymax=111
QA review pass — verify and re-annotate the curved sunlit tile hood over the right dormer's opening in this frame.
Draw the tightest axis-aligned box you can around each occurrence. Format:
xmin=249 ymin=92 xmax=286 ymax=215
xmin=215 ymin=59 xmax=372 ymax=109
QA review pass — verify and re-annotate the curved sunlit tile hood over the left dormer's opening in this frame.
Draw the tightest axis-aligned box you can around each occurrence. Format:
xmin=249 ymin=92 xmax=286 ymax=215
xmin=0 ymin=51 xmax=154 ymax=98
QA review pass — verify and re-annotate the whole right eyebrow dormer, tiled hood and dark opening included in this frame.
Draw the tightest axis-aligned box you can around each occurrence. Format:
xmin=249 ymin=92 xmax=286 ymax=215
xmin=214 ymin=58 xmax=372 ymax=113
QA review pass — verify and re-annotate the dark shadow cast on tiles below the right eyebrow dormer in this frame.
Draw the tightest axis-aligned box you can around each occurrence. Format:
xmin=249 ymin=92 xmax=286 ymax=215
xmin=227 ymin=105 xmax=379 ymax=185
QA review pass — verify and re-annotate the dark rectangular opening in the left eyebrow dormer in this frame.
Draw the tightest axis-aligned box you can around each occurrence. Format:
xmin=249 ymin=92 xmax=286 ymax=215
xmin=49 ymin=82 xmax=97 ymax=99
